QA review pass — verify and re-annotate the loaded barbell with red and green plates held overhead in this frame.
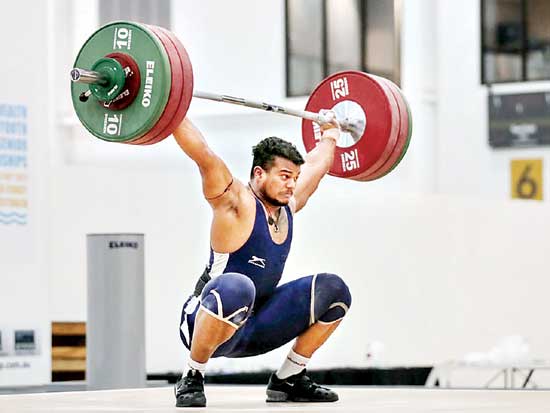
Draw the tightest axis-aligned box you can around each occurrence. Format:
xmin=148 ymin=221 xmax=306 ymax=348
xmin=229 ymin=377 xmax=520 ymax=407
xmin=70 ymin=21 xmax=412 ymax=181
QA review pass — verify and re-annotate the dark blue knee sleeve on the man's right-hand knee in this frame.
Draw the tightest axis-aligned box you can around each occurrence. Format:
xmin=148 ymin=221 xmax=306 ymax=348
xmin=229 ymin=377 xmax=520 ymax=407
xmin=310 ymin=273 xmax=351 ymax=324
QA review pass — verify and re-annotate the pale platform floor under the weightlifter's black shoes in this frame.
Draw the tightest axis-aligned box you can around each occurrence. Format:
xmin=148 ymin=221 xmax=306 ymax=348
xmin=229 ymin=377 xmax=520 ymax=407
xmin=0 ymin=385 xmax=550 ymax=413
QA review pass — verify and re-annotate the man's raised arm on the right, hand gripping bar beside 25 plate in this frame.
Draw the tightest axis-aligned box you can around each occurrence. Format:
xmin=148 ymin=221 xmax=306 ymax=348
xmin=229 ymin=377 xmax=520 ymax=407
xmin=294 ymin=121 xmax=340 ymax=212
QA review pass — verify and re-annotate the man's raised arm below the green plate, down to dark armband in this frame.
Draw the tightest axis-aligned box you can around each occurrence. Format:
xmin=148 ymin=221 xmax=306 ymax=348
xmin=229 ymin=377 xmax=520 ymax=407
xmin=173 ymin=118 xmax=233 ymax=204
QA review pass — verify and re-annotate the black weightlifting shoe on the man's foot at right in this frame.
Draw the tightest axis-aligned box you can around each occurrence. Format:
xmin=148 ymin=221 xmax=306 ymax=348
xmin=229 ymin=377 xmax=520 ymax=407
xmin=266 ymin=369 xmax=338 ymax=402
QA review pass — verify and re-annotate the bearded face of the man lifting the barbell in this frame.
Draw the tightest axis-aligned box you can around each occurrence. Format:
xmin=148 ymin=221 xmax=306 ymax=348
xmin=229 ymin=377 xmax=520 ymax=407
xmin=258 ymin=157 xmax=300 ymax=206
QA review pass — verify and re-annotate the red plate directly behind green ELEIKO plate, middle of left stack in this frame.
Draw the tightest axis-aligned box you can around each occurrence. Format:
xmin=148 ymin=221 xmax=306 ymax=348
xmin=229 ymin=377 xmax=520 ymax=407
xmin=127 ymin=25 xmax=183 ymax=145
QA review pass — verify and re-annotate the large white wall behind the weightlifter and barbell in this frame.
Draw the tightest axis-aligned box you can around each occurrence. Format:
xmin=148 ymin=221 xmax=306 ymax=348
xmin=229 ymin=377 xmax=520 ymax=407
xmin=44 ymin=0 xmax=550 ymax=372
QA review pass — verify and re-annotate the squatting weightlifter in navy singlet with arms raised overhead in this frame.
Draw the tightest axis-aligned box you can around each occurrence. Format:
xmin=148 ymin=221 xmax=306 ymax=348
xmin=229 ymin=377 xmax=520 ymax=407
xmin=173 ymin=113 xmax=351 ymax=407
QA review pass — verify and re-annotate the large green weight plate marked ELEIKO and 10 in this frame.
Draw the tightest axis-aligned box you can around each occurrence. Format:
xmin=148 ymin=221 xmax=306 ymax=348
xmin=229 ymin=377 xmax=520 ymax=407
xmin=71 ymin=21 xmax=171 ymax=142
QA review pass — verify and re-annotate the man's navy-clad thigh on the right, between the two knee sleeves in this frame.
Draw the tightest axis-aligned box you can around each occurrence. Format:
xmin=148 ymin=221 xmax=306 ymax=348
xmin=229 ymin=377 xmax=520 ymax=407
xmin=214 ymin=275 xmax=313 ymax=357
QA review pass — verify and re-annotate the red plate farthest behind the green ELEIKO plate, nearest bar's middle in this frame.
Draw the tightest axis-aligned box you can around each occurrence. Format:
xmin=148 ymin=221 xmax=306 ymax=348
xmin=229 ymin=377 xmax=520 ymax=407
xmin=139 ymin=27 xmax=193 ymax=144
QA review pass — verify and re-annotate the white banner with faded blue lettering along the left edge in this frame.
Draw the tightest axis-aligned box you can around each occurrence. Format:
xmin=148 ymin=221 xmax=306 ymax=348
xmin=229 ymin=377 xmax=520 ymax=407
xmin=0 ymin=0 xmax=52 ymax=386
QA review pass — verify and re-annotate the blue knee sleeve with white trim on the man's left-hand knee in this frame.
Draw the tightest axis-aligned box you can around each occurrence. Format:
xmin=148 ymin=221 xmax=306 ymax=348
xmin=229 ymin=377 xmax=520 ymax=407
xmin=201 ymin=273 xmax=256 ymax=328
